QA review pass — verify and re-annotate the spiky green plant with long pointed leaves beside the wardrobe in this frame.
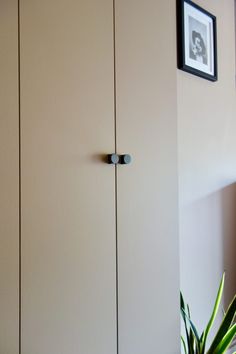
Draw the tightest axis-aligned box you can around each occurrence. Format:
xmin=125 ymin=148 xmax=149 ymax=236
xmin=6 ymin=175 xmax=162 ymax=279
xmin=180 ymin=274 xmax=236 ymax=354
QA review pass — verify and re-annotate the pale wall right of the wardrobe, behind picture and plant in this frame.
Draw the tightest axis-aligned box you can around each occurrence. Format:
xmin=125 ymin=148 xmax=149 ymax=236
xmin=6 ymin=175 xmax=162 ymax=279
xmin=177 ymin=0 xmax=236 ymax=338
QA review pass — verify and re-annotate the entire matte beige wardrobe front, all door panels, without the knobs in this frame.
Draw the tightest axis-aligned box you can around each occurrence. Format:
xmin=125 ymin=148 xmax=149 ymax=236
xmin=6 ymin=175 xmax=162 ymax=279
xmin=0 ymin=0 xmax=180 ymax=354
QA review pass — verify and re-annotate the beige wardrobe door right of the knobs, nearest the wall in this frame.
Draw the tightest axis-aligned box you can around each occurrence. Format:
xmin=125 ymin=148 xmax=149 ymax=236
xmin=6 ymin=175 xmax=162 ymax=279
xmin=116 ymin=0 xmax=180 ymax=354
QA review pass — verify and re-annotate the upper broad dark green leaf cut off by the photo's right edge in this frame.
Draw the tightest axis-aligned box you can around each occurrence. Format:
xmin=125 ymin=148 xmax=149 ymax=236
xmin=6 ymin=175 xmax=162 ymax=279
xmin=209 ymin=295 xmax=236 ymax=353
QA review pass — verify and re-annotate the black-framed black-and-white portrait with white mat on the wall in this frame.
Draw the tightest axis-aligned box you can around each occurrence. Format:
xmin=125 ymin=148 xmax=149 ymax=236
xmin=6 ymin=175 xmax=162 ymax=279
xmin=177 ymin=0 xmax=217 ymax=81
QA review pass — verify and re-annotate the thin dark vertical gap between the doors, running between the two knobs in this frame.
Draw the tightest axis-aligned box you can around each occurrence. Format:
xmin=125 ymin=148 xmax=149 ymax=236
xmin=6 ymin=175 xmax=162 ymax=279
xmin=113 ymin=0 xmax=119 ymax=354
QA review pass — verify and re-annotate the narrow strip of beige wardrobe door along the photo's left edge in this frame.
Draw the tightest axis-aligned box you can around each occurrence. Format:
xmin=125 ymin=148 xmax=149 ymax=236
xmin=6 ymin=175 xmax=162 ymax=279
xmin=0 ymin=0 xmax=19 ymax=354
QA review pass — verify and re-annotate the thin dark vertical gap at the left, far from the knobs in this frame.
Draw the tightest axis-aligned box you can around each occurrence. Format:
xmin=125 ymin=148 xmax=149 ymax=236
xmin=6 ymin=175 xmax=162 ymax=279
xmin=17 ymin=0 xmax=21 ymax=354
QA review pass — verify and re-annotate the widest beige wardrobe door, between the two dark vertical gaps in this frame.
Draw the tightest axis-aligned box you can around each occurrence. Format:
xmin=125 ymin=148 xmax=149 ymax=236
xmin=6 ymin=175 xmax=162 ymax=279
xmin=20 ymin=0 xmax=116 ymax=354
